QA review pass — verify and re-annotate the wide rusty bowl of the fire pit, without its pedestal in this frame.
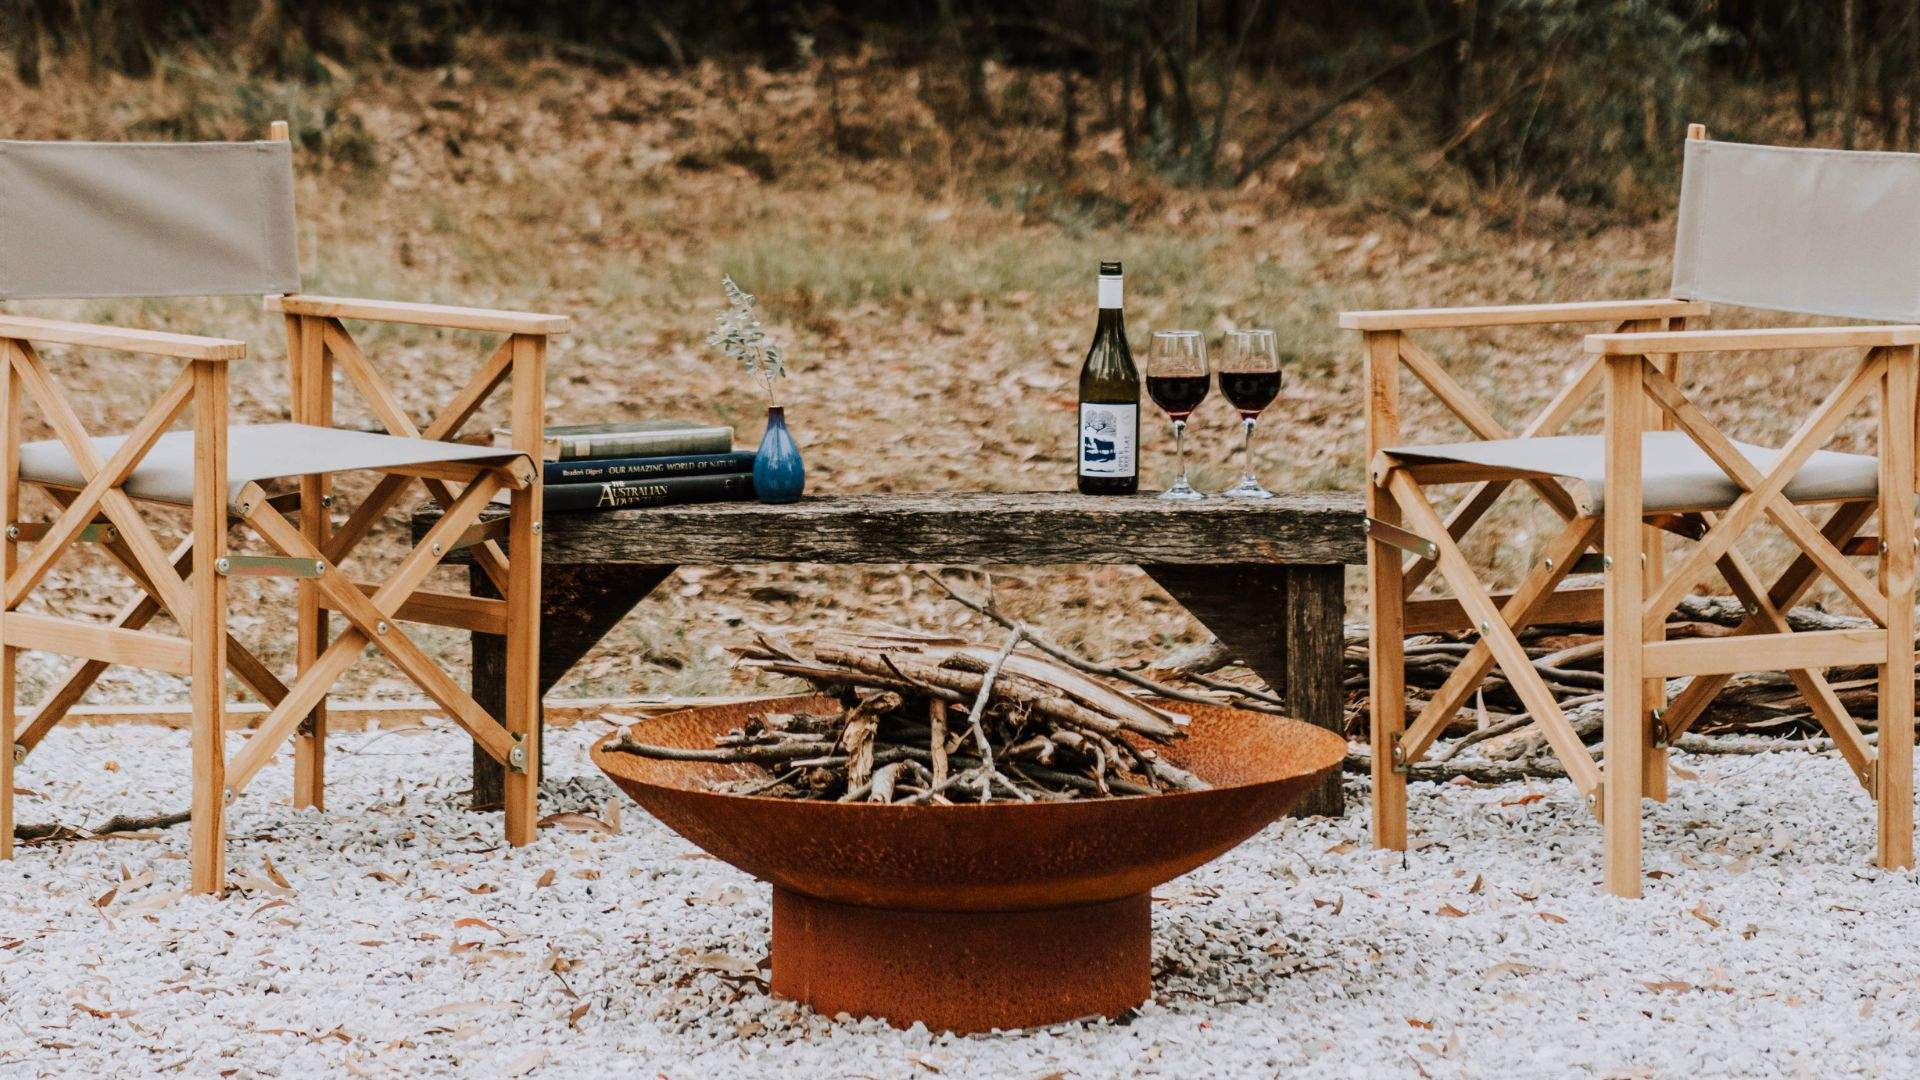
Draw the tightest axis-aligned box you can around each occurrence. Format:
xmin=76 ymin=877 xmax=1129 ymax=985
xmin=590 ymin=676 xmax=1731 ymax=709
xmin=593 ymin=698 xmax=1346 ymax=911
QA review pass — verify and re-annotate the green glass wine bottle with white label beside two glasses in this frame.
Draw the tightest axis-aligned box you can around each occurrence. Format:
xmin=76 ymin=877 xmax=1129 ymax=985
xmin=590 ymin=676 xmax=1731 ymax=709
xmin=1075 ymin=263 xmax=1140 ymax=496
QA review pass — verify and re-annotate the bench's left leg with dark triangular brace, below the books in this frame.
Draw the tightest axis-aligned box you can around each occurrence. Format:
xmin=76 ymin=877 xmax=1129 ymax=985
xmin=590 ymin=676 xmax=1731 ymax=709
xmin=468 ymin=567 xmax=674 ymax=811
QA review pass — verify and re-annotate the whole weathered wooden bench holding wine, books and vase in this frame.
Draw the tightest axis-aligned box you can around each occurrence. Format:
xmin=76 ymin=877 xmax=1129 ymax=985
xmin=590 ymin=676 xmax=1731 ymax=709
xmin=413 ymin=492 xmax=1365 ymax=815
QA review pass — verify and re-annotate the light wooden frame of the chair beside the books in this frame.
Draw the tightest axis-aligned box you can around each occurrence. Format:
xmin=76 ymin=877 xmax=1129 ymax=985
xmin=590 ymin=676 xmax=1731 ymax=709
xmin=0 ymin=123 xmax=570 ymax=894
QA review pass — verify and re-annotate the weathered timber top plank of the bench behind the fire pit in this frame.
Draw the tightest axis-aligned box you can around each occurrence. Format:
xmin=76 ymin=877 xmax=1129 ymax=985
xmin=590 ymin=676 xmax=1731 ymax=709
xmin=415 ymin=492 xmax=1367 ymax=567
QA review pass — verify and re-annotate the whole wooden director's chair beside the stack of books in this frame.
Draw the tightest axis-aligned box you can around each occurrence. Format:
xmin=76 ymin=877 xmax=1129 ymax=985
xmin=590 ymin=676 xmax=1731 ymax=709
xmin=0 ymin=123 xmax=568 ymax=894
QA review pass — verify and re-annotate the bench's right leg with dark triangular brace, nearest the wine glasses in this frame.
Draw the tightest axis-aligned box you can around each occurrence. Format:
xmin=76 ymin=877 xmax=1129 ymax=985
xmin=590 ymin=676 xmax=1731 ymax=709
xmin=1140 ymin=563 xmax=1346 ymax=817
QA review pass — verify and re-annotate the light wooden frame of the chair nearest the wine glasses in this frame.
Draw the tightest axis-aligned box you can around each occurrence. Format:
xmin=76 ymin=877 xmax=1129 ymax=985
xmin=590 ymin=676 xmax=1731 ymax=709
xmin=1342 ymin=300 xmax=1920 ymax=896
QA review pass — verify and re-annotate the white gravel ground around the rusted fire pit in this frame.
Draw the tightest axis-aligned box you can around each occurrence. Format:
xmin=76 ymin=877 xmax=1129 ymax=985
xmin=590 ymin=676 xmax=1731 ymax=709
xmin=0 ymin=714 xmax=1920 ymax=1080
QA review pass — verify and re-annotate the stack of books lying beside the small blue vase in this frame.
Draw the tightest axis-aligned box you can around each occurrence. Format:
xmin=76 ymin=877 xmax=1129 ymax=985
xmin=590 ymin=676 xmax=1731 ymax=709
xmin=543 ymin=421 xmax=753 ymax=511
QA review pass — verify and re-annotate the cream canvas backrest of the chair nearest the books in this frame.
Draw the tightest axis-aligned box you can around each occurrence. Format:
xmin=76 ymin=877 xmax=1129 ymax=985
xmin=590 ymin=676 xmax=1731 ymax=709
xmin=0 ymin=138 xmax=300 ymax=300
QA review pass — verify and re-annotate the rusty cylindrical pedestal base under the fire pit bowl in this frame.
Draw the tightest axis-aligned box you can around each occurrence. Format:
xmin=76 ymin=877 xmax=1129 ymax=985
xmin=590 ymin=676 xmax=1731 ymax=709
xmin=772 ymin=888 xmax=1152 ymax=1032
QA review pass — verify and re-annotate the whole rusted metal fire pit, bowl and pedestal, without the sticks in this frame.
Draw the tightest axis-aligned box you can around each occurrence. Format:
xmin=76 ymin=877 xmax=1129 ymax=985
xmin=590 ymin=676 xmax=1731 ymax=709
xmin=593 ymin=696 xmax=1346 ymax=1032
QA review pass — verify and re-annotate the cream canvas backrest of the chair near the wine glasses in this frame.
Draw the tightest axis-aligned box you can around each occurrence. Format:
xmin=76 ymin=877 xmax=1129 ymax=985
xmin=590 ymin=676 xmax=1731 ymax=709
xmin=1672 ymin=138 xmax=1920 ymax=323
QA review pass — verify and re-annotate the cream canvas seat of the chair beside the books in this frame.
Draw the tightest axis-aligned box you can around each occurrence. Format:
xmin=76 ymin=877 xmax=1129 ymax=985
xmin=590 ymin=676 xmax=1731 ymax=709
xmin=19 ymin=423 xmax=524 ymax=507
